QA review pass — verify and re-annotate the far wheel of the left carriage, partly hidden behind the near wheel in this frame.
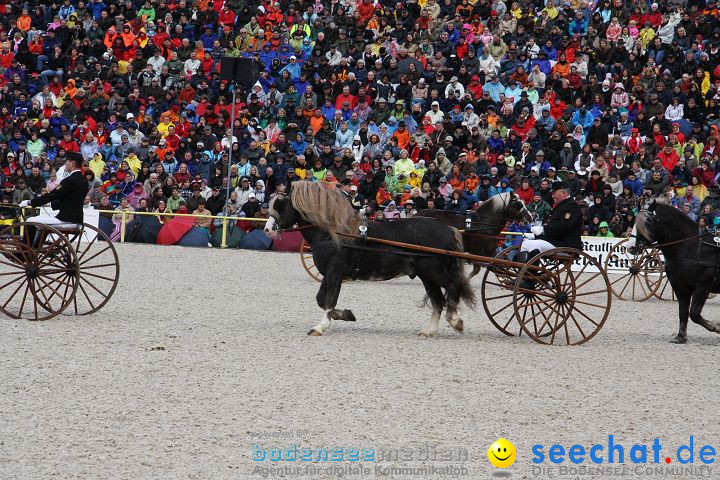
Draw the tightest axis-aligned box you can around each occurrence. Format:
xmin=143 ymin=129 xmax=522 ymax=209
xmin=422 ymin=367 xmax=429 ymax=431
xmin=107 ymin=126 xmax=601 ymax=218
xmin=65 ymin=224 xmax=120 ymax=315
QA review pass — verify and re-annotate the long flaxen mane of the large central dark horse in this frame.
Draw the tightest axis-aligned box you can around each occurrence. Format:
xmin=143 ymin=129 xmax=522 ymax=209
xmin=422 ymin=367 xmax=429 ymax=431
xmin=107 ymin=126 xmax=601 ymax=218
xmin=290 ymin=182 xmax=362 ymax=243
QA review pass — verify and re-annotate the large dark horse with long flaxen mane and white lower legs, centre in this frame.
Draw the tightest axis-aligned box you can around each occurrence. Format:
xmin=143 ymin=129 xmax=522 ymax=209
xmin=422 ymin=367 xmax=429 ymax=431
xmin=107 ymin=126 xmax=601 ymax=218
xmin=265 ymin=182 xmax=475 ymax=337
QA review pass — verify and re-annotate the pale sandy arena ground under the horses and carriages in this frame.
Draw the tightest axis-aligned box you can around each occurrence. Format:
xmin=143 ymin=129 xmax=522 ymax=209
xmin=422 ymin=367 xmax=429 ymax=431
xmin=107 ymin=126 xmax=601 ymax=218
xmin=0 ymin=245 xmax=720 ymax=480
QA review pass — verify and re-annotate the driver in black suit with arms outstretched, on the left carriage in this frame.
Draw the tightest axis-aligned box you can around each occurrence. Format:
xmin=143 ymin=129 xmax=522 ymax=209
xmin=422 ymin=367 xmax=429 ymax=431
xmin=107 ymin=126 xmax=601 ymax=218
xmin=20 ymin=154 xmax=90 ymax=227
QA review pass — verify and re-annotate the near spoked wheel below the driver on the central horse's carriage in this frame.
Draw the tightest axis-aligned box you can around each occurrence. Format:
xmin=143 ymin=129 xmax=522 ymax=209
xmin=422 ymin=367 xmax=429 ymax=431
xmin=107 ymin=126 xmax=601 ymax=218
xmin=513 ymin=248 xmax=612 ymax=345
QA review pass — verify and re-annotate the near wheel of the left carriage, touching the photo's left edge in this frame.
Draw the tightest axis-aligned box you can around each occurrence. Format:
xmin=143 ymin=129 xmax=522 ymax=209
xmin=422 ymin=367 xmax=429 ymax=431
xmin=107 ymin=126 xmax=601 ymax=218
xmin=0 ymin=222 xmax=79 ymax=320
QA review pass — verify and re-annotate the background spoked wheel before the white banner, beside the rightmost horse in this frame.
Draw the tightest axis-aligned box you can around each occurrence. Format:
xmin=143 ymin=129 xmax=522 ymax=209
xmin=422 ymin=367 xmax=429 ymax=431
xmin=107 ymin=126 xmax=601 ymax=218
xmin=605 ymin=239 xmax=664 ymax=302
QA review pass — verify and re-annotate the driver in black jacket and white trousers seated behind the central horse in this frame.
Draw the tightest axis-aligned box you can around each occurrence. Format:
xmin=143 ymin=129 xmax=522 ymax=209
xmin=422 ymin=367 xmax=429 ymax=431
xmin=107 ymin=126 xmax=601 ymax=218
xmin=518 ymin=181 xmax=583 ymax=262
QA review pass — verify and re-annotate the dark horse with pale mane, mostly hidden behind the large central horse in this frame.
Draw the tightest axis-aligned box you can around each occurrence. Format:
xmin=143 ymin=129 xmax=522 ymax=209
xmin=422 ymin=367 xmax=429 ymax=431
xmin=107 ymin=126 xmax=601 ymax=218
xmin=416 ymin=192 xmax=533 ymax=278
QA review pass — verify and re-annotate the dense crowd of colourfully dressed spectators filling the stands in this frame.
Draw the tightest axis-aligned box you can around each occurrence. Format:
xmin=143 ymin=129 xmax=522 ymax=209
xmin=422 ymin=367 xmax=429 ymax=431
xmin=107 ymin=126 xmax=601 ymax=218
xmin=0 ymin=0 xmax=720 ymax=240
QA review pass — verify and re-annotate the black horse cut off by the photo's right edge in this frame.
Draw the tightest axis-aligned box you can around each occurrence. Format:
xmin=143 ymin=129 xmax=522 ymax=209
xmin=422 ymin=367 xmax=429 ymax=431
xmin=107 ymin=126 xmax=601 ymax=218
xmin=628 ymin=201 xmax=720 ymax=343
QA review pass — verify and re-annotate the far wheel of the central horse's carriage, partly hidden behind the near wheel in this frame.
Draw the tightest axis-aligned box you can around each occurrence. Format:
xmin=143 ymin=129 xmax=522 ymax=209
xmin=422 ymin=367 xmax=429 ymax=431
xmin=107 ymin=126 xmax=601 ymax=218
xmin=481 ymin=245 xmax=522 ymax=337
